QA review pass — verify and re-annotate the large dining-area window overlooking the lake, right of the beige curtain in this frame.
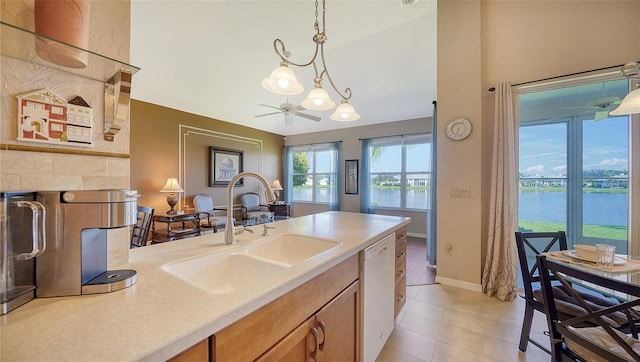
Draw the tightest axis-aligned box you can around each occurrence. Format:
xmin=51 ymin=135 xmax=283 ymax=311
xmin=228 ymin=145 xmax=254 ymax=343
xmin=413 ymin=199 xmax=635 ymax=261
xmin=518 ymin=79 xmax=630 ymax=254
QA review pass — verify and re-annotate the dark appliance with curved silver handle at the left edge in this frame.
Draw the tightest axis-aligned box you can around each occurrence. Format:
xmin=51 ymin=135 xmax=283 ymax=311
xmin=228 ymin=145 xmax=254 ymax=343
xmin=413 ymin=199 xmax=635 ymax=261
xmin=0 ymin=192 xmax=46 ymax=314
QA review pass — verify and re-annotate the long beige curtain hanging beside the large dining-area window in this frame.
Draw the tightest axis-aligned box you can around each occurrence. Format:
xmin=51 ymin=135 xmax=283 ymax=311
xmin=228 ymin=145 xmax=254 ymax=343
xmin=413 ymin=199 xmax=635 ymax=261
xmin=482 ymin=83 xmax=518 ymax=301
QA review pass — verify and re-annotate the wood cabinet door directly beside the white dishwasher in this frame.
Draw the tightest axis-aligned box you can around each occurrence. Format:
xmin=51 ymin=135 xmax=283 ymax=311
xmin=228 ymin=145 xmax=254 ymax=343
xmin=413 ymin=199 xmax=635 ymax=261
xmin=316 ymin=281 xmax=360 ymax=362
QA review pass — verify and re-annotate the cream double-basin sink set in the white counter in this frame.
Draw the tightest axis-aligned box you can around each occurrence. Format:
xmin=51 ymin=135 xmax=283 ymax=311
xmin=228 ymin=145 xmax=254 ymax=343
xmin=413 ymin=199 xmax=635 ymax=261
xmin=162 ymin=234 xmax=342 ymax=294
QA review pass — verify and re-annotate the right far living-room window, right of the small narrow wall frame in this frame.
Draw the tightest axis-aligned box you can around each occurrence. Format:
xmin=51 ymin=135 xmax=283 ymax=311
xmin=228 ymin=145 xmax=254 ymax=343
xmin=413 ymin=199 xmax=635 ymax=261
xmin=363 ymin=134 xmax=431 ymax=210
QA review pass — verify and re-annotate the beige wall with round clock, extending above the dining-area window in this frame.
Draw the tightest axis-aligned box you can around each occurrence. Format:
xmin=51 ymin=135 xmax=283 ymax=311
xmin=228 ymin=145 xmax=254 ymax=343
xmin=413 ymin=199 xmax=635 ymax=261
xmin=438 ymin=0 xmax=640 ymax=290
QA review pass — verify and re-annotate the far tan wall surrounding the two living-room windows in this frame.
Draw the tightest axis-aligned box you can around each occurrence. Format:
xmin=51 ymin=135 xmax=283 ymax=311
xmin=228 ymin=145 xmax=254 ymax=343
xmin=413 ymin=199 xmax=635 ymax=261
xmin=285 ymin=117 xmax=431 ymax=237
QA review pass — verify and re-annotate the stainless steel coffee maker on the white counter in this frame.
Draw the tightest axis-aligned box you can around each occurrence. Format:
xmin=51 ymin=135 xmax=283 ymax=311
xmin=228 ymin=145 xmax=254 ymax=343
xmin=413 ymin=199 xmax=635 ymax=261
xmin=36 ymin=190 xmax=138 ymax=297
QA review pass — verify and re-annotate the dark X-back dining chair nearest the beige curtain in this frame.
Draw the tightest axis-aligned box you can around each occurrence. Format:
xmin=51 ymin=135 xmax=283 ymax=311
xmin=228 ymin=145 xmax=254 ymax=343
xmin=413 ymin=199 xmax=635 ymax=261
xmin=516 ymin=231 xmax=567 ymax=353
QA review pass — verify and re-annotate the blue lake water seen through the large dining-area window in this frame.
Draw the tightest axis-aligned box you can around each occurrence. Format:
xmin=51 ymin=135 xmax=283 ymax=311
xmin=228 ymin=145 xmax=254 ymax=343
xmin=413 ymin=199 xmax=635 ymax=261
xmin=518 ymin=192 xmax=628 ymax=226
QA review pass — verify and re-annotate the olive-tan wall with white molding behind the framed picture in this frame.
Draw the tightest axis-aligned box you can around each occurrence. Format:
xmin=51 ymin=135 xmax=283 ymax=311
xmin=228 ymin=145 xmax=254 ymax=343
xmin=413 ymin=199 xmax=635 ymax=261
xmin=131 ymin=100 xmax=284 ymax=222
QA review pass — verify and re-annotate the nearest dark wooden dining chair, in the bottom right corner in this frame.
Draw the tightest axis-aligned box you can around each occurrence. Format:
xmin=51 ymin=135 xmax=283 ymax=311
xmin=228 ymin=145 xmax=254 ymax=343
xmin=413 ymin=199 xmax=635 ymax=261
xmin=536 ymin=255 xmax=640 ymax=361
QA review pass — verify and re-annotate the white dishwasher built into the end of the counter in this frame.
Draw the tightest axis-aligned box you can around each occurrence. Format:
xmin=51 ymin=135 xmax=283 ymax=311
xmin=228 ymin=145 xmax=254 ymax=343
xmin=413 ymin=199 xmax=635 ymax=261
xmin=360 ymin=233 xmax=396 ymax=362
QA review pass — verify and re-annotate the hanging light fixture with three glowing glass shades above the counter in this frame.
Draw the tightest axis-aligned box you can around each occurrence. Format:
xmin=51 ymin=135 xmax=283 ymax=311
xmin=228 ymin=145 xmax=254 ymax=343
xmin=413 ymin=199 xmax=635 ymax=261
xmin=262 ymin=0 xmax=360 ymax=121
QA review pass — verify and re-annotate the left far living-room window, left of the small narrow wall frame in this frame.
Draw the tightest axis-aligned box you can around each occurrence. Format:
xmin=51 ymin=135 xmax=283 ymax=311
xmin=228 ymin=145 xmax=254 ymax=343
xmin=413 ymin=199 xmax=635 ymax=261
xmin=285 ymin=143 xmax=340 ymax=204
